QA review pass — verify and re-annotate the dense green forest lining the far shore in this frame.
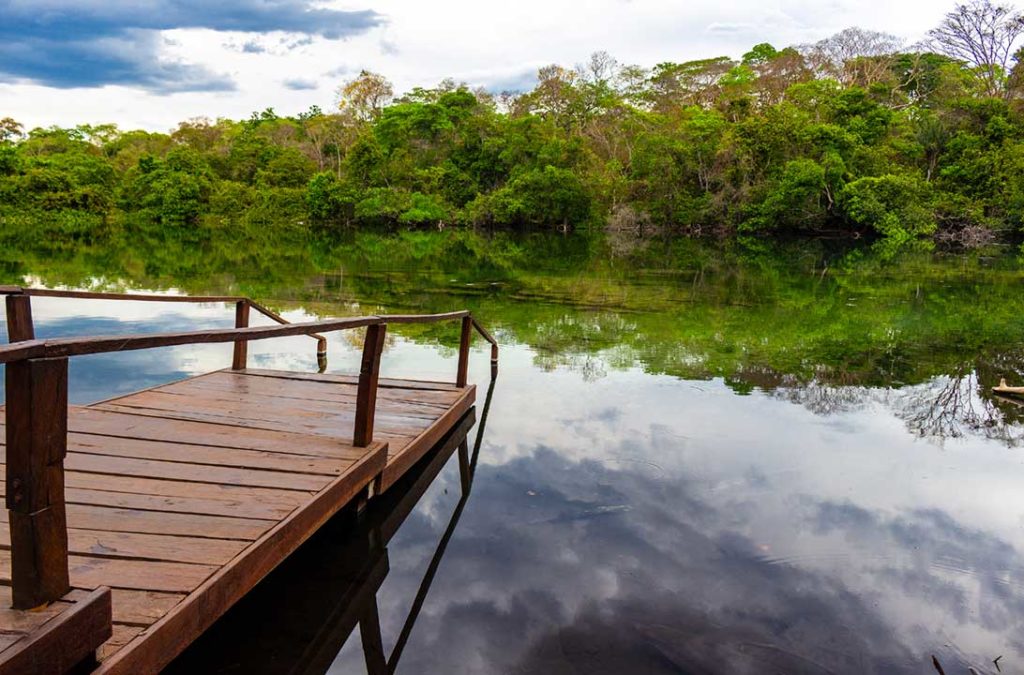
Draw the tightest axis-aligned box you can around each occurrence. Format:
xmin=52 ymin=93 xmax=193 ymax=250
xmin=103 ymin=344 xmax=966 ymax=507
xmin=0 ymin=0 xmax=1024 ymax=245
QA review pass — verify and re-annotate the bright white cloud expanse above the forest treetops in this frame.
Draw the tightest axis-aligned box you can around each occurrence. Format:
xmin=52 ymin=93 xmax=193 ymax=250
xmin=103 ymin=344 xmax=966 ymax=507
xmin=0 ymin=0 xmax=991 ymax=130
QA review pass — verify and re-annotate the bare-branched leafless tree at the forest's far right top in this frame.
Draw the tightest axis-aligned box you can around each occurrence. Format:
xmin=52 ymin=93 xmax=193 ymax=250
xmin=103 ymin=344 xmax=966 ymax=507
xmin=928 ymin=0 xmax=1024 ymax=98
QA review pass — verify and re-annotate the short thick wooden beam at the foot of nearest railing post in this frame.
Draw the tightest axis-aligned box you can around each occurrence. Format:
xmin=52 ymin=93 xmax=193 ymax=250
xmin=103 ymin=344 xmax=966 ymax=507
xmin=0 ymin=586 xmax=113 ymax=675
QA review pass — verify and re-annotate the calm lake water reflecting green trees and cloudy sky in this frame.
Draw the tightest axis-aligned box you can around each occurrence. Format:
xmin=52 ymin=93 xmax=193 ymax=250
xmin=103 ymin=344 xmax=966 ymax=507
xmin=0 ymin=235 xmax=1024 ymax=673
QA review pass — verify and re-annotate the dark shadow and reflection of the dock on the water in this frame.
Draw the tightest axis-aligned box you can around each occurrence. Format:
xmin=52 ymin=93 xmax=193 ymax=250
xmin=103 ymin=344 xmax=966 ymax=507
xmin=163 ymin=378 xmax=496 ymax=675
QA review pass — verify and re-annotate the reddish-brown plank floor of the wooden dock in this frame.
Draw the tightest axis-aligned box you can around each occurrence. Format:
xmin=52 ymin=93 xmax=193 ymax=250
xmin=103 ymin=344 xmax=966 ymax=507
xmin=0 ymin=370 xmax=475 ymax=673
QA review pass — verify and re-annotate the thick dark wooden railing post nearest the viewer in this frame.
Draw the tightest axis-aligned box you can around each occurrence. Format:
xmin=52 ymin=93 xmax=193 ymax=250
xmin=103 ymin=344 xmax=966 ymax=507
xmin=6 ymin=358 xmax=71 ymax=609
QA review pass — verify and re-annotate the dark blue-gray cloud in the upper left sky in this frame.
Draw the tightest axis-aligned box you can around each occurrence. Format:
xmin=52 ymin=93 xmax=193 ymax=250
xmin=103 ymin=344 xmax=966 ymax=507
xmin=0 ymin=0 xmax=381 ymax=93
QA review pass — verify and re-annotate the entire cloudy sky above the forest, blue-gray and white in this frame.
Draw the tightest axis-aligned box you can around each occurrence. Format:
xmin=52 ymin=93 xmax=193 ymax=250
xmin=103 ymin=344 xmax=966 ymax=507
xmin=0 ymin=0 xmax=1007 ymax=130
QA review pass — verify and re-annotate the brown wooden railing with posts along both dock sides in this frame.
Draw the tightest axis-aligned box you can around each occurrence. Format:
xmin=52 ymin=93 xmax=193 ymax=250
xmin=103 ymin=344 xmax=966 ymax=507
xmin=0 ymin=286 xmax=498 ymax=609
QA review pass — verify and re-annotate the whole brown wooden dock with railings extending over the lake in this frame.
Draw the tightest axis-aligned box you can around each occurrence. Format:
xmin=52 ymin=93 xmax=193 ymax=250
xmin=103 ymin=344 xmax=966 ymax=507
xmin=0 ymin=288 xmax=497 ymax=675
